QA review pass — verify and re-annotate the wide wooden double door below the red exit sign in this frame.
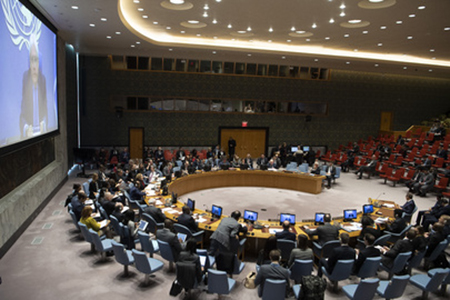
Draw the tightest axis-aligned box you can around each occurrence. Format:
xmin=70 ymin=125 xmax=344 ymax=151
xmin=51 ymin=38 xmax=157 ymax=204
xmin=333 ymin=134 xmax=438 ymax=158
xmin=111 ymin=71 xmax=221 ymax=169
xmin=220 ymin=128 xmax=268 ymax=158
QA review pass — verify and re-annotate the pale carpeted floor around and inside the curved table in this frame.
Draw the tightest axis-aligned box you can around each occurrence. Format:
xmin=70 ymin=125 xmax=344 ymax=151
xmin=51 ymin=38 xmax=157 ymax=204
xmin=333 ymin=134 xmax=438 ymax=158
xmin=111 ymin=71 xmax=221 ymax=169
xmin=0 ymin=168 xmax=448 ymax=300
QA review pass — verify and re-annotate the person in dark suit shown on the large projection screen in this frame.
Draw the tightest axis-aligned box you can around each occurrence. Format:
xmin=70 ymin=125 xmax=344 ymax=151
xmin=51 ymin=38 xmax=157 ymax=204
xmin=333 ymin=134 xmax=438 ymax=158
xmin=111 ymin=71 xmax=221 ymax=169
xmin=20 ymin=34 xmax=48 ymax=139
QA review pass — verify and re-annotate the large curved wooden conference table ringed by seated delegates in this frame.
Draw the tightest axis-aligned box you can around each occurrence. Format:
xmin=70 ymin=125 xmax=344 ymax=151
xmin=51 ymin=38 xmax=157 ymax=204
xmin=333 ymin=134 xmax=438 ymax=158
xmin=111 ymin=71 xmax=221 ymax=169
xmin=146 ymin=170 xmax=398 ymax=249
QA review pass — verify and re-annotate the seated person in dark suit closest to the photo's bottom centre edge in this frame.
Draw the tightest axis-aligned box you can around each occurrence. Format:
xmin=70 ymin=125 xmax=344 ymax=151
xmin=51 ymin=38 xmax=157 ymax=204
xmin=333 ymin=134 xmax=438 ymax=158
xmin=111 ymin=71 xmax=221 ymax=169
xmin=255 ymin=250 xmax=290 ymax=297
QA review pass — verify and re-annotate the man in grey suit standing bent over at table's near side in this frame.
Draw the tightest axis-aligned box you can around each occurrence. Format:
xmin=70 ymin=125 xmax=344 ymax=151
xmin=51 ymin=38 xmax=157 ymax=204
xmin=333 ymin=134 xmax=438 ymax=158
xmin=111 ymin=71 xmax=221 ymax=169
xmin=209 ymin=210 xmax=247 ymax=255
